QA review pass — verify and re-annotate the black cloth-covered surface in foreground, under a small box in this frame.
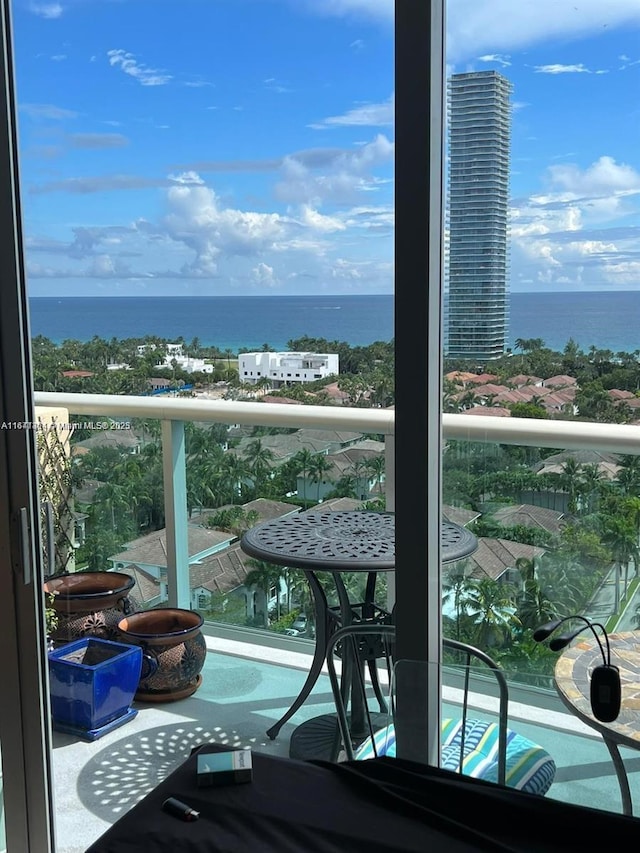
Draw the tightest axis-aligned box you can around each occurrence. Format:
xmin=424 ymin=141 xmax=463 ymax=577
xmin=87 ymin=746 xmax=640 ymax=853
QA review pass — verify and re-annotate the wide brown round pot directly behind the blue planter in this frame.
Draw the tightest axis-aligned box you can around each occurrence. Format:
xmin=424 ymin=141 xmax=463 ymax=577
xmin=44 ymin=572 xmax=140 ymax=646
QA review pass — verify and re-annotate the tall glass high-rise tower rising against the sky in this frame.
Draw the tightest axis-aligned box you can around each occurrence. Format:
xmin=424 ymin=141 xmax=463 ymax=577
xmin=445 ymin=71 xmax=512 ymax=363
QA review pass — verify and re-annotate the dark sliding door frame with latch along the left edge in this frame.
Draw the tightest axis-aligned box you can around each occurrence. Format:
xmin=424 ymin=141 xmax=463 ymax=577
xmin=0 ymin=0 xmax=52 ymax=853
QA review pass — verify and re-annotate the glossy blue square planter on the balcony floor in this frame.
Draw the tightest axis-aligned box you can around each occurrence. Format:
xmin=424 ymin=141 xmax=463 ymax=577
xmin=49 ymin=637 xmax=142 ymax=740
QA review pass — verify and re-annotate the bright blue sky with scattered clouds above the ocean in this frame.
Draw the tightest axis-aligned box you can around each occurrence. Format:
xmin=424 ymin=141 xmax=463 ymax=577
xmin=8 ymin=0 xmax=640 ymax=296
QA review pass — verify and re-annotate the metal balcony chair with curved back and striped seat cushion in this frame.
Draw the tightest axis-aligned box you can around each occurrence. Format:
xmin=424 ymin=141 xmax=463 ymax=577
xmin=327 ymin=625 xmax=556 ymax=795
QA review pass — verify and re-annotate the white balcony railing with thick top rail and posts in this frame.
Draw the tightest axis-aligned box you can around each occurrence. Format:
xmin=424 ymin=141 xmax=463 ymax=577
xmin=35 ymin=391 xmax=640 ymax=608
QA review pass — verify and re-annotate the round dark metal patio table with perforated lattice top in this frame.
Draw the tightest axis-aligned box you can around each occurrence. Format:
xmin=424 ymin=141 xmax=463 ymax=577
xmin=240 ymin=510 xmax=477 ymax=758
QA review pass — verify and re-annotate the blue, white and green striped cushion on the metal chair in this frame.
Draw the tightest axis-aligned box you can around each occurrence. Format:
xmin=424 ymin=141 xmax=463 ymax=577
xmin=356 ymin=720 xmax=556 ymax=794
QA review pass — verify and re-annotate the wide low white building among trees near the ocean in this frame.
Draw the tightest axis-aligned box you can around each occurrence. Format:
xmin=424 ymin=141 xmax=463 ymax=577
xmin=238 ymin=352 xmax=340 ymax=388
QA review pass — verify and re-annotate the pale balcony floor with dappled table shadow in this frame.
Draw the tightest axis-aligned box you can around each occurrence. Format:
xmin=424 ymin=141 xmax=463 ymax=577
xmin=53 ymin=636 xmax=640 ymax=853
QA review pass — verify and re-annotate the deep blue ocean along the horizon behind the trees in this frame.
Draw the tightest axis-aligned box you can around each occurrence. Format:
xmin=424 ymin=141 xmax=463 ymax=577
xmin=29 ymin=291 xmax=640 ymax=352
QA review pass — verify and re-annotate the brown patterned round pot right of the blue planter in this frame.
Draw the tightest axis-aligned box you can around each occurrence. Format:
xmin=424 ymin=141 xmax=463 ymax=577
xmin=118 ymin=607 xmax=207 ymax=702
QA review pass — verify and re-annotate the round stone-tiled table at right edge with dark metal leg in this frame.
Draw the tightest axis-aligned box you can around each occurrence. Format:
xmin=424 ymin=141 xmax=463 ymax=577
xmin=554 ymin=631 xmax=640 ymax=815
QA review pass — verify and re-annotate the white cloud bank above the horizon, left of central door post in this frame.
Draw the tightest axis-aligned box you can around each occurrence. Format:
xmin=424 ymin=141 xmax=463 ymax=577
xmin=26 ymin=168 xmax=393 ymax=292
